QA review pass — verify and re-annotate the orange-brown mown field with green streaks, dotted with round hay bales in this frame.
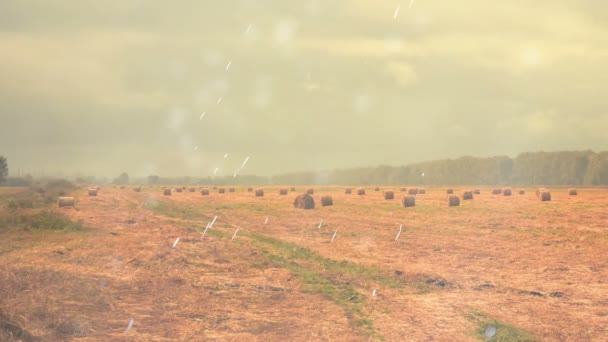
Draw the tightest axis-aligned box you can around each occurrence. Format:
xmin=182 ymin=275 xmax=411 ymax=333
xmin=0 ymin=186 xmax=608 ymax=341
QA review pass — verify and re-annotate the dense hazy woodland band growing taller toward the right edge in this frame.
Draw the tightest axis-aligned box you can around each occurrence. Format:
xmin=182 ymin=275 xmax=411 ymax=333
xmin=272 ymin=151 xmax=608 ymax=186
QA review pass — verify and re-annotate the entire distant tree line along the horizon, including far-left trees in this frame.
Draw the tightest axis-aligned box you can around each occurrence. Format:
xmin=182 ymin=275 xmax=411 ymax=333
xmin=0 ymin=151 xmax=608 ymax=186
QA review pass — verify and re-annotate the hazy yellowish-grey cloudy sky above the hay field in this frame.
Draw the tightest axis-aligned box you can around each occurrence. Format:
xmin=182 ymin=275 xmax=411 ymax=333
xmin=0 ymin=0 xmax=608 ymax=176
